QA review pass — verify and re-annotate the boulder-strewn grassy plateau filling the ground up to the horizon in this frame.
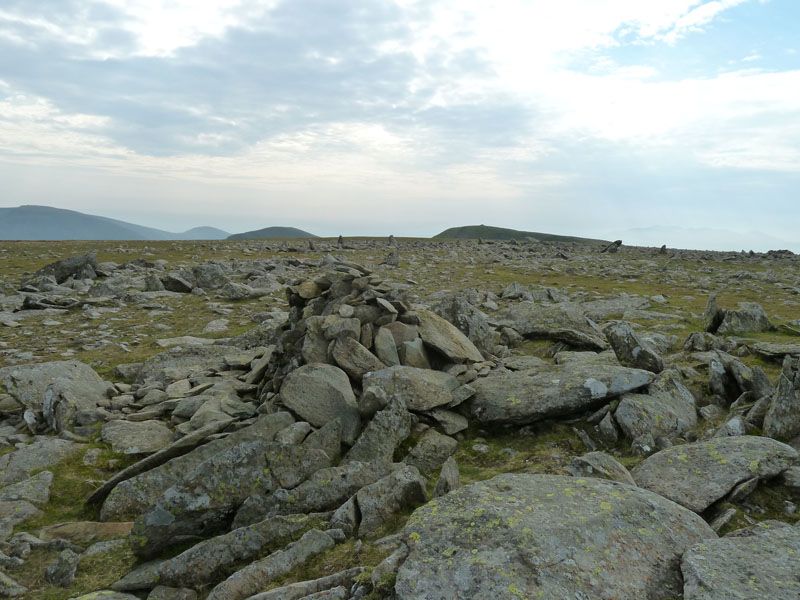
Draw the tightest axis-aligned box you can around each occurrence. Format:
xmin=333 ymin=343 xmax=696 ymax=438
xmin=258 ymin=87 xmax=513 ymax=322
xmin=0 ymin=237 xmax=800 ymax=600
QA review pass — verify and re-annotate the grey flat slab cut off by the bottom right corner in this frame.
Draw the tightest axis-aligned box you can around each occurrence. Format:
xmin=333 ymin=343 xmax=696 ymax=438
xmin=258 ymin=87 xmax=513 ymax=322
xmin=681 ymin=521 xmax=800 ymax=600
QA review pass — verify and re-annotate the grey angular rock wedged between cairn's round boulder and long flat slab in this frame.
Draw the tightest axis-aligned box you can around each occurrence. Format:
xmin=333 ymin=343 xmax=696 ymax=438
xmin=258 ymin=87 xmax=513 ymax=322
xmin=363 ymin=366 xmax=461 ymax=411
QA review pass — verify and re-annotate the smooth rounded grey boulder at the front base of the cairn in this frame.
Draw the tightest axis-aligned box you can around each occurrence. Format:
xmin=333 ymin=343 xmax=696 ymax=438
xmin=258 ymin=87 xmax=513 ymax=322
xmin=280 ymin=363 xmax=361 ymax=445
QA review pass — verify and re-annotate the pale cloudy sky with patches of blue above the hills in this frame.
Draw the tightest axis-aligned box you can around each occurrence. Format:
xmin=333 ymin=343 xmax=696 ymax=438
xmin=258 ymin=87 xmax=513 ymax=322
xmin=0 ymin=0 xmax=800 ymax=251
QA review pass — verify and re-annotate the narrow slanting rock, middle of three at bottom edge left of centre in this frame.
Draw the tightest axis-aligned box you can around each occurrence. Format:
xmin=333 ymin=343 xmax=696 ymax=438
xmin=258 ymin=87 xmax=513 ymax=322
xmin=207 ymin=529 xmax=336 ymax=600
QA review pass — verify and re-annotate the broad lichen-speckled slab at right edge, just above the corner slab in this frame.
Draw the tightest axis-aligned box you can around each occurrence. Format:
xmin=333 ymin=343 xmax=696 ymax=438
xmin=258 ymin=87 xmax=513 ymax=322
xmin=631 ymin=435 xmax=798 ymax=513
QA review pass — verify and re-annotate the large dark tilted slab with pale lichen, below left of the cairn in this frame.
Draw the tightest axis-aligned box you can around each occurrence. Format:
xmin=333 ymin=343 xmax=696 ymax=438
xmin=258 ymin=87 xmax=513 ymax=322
xmin=131 ymin=441 xmax=330 ymax=557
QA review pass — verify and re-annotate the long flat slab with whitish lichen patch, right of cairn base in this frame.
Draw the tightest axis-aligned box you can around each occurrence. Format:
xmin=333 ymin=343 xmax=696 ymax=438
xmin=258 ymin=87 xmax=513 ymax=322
xmin=470 ymin=363 xmax=654 ymax=425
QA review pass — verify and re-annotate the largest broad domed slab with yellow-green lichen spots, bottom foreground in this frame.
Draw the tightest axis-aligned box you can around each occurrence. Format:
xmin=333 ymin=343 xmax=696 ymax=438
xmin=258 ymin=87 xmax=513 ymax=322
xmin=395 ymin=474 xmax=716 ymax=600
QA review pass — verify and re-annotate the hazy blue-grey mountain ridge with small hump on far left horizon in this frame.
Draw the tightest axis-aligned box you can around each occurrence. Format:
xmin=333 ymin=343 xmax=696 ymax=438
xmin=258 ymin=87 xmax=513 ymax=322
xmin=0 ymin=205 xmax=228 ymax=240
